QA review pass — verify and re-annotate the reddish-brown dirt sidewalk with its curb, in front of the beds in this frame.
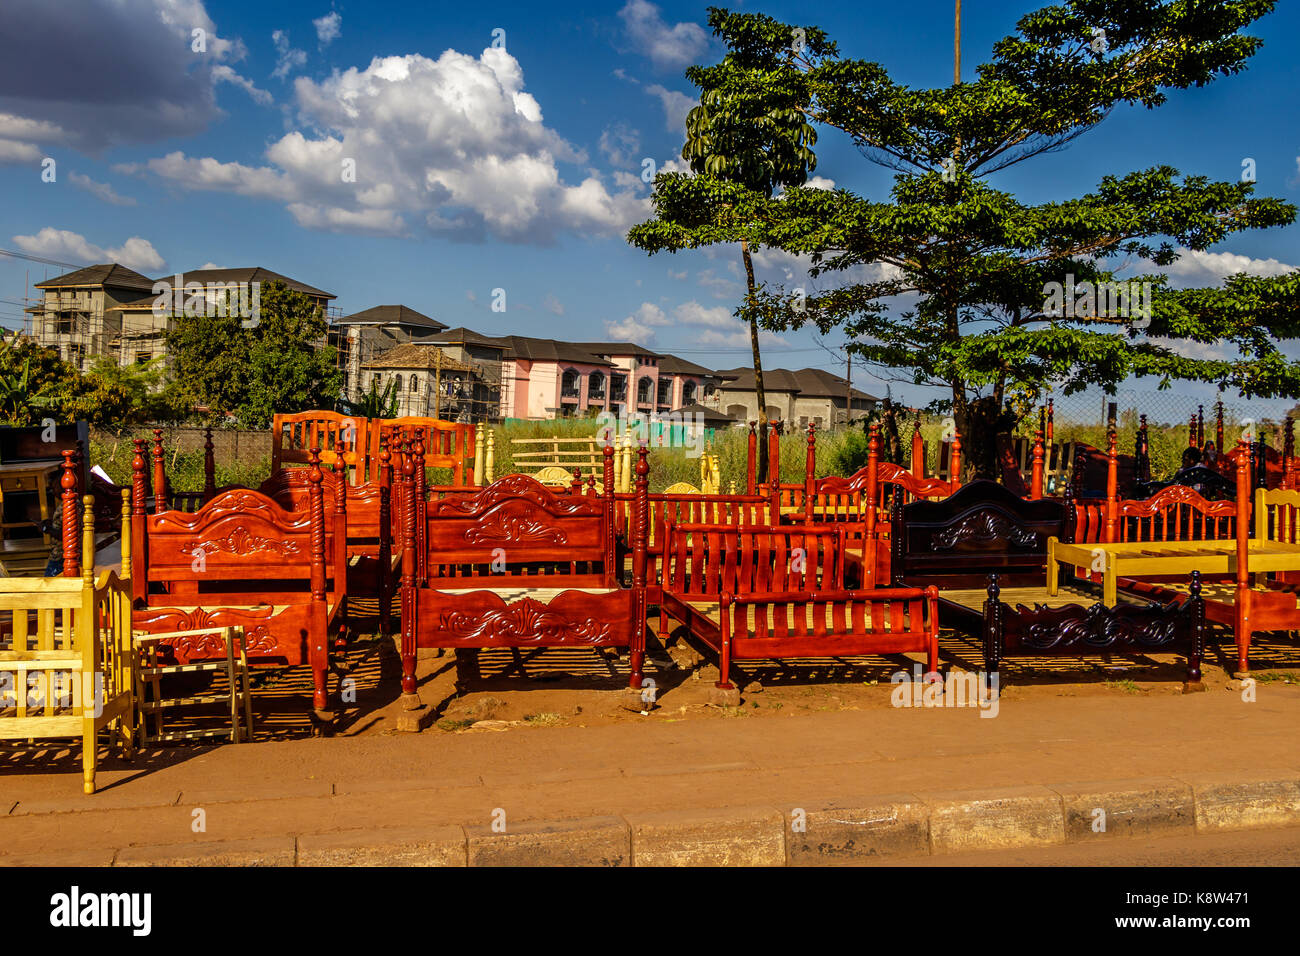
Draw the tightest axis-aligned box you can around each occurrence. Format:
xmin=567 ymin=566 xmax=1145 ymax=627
xmin=0 ymin=683 xmax=1300 ymax=865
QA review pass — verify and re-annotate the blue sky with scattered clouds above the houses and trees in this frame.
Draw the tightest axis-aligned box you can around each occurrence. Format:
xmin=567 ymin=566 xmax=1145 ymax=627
xmin=0 ymin=0 xmax=1300 ymax=416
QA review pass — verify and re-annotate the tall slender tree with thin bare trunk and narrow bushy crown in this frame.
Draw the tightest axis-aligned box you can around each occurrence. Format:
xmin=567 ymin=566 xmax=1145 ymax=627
xmin=628 ymin=18 xmax=823 ymax=477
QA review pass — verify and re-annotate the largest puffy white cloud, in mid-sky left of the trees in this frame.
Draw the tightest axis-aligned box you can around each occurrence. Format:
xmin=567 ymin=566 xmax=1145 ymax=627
xmin=133 ymin=48 xmax=649 ymax=243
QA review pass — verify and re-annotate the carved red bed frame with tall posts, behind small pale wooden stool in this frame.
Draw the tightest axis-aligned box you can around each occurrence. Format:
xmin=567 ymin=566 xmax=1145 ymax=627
xmin=130 ymin=451 xmax=347 ymax=717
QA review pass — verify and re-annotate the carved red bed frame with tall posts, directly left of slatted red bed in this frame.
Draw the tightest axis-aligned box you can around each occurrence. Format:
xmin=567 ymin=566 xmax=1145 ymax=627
xmin=399 ymin=442 xmax=649 ymax=709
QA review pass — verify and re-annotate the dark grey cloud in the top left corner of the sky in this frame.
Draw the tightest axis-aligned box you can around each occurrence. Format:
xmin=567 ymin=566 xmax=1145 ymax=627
xmin=0 ymin=0 xmax=247 ymax=152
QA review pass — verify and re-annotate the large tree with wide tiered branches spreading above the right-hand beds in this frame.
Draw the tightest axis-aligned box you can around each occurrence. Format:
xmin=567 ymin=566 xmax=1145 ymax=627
xmin=626 ymin=0 xmax=1300 ymax=476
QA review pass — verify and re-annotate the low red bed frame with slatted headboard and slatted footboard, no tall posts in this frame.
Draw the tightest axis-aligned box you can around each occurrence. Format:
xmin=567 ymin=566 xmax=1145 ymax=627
xmin=658 ymin=515 xmax=939 ymax=702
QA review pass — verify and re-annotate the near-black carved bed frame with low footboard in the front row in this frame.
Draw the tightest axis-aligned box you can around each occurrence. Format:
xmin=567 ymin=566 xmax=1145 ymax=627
xmin=892 ymin=481 xmax=1205 ymax=691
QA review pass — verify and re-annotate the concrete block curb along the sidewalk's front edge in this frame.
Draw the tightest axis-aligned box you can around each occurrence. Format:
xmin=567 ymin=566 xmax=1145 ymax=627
xmin=27 ymin=771 xmax=1300 ymax=866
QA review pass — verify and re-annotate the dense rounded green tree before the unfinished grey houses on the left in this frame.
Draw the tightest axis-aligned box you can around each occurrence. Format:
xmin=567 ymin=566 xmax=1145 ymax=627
xmin=168 ymin=282 xmax=343 ymax=428
